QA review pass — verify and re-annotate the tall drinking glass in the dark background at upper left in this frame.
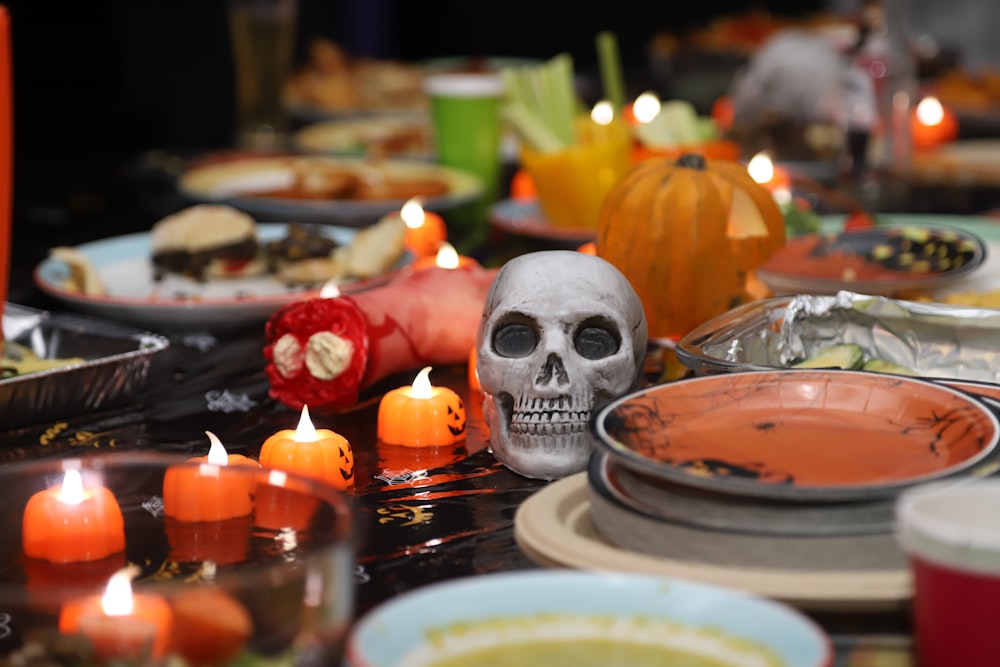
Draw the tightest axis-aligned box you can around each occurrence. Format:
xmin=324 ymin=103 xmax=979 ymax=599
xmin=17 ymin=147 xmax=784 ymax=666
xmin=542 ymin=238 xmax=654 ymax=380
xmin=228 ymin=0 xmax=298 ymax=151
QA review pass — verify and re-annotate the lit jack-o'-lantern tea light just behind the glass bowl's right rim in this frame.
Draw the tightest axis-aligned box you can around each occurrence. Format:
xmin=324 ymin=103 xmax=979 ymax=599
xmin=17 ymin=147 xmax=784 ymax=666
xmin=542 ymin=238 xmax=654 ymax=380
xmin=260 ymin=406 xmax=354 ymax=490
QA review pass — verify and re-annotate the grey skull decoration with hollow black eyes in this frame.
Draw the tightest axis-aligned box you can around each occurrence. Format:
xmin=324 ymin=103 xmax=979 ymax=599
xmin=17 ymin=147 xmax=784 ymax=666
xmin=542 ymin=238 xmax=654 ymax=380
xmin=476 ymin=250 xmax=647 ymax=479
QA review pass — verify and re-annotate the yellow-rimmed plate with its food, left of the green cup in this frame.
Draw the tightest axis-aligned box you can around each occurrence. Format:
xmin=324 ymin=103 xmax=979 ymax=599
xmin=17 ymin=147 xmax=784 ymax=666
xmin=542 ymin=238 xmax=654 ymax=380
xmin=177 ymin=155 xmax=482 ymax=227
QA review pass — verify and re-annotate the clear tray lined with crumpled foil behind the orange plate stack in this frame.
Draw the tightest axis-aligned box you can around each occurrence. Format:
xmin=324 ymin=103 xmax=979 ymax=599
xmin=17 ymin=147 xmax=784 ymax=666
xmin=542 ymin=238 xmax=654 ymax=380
xmin=677 ymin=291 xmax=1000 ymax=383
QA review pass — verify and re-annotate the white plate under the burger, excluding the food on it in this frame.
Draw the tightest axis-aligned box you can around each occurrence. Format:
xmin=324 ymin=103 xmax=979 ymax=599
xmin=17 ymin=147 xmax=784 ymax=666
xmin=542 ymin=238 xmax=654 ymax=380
xmin=35 ymin=223 xmax=412 ymax=330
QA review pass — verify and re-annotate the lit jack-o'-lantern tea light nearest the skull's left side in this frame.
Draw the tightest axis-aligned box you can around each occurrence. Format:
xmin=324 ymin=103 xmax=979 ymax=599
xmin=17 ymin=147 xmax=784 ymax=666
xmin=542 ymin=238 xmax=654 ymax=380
xmin=378 ymin=366 xmax=465 ymax=447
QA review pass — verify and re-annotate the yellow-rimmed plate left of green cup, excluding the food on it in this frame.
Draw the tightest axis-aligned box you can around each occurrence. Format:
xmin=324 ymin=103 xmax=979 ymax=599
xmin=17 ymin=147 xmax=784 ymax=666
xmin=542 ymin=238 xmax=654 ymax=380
xmin=177 ymin=156 xmax=482 ymax=227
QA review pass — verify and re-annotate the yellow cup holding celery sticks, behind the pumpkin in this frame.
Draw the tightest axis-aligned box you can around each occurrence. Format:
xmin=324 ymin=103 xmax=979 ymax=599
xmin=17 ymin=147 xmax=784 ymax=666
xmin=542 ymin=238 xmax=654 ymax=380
xmin=520 ymin=117 xmax=632 ymax=230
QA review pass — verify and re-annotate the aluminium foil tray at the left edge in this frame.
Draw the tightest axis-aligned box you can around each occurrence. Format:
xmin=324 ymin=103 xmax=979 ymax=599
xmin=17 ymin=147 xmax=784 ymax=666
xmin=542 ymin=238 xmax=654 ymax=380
xmin=0 ymin=303 xmax=170 ymax=429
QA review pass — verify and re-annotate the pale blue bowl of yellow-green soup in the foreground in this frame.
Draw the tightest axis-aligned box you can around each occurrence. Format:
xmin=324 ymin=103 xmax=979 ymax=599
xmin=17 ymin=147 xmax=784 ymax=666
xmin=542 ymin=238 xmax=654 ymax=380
xmin=347 ymin=570 xmax=832 ymax=667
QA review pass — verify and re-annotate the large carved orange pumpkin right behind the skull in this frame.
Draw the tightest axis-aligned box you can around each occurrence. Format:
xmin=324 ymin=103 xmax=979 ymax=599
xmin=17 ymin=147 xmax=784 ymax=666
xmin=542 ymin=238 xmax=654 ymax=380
xmin=597 ymin=153 xmax=785 ymax=338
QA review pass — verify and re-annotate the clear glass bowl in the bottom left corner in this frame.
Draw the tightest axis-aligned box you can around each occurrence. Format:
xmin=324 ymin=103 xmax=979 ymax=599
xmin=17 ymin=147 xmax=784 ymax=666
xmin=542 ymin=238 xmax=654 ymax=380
xmin=0 ymin=453 xmax=355 ymax=666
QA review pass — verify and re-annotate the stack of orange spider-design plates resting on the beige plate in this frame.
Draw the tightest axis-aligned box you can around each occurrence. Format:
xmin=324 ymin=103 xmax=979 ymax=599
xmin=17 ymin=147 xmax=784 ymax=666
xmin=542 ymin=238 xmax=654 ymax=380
xmin=588 ymin=370 xmax=1000 ymax=571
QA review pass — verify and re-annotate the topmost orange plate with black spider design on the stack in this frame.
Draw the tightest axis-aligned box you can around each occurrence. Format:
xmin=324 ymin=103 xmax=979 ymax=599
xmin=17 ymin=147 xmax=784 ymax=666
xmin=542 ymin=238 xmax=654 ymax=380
xmin=595 ymin=370 xmax=1000 ymax=500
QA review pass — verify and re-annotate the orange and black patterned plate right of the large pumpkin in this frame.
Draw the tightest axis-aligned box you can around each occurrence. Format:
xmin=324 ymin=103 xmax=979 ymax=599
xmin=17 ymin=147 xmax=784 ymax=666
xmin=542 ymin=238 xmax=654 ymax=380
xmin=758 ymin=224 xmax=986 ymax=296
